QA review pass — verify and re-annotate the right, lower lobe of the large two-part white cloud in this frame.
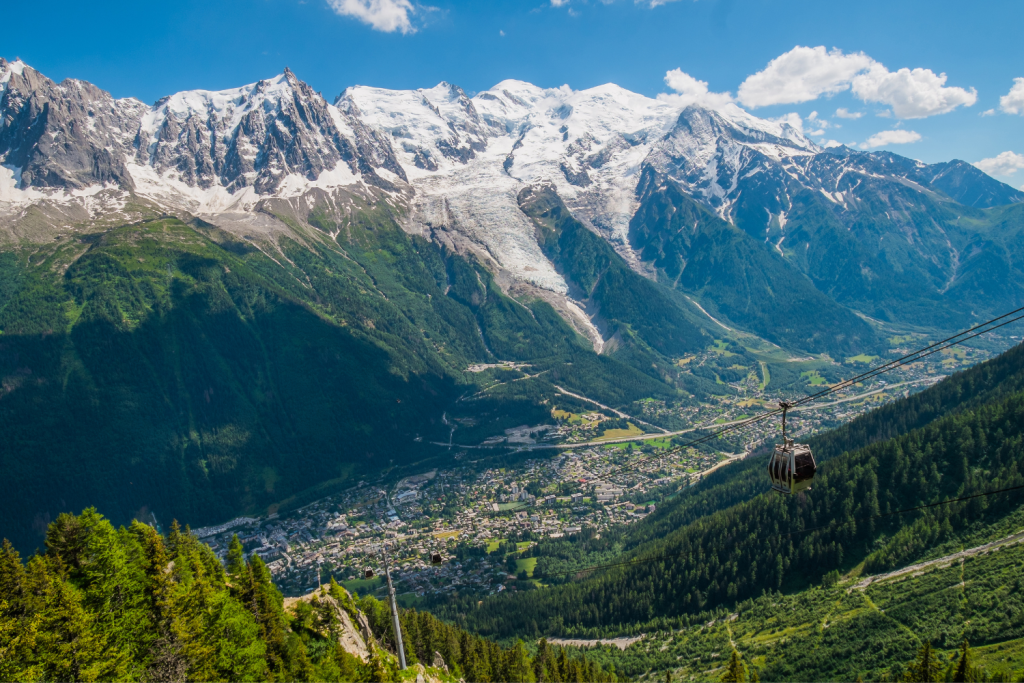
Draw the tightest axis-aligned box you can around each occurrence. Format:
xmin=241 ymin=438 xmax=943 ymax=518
xmin=853 ymin=62 xmax=978 ymax=119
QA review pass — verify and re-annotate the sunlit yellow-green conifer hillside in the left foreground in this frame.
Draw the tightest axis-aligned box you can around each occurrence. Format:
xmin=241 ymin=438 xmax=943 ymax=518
xmin=0 ymin=509 xmax=615 ymax=682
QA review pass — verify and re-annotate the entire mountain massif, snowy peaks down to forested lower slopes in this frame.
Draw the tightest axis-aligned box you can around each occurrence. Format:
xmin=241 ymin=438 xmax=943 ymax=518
xmin=0 ymin=54 xmax=1024 ymax=561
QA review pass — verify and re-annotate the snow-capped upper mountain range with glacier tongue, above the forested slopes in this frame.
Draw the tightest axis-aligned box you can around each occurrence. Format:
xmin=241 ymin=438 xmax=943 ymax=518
xmin=0 ymin=59 xmax=1024 ymax=348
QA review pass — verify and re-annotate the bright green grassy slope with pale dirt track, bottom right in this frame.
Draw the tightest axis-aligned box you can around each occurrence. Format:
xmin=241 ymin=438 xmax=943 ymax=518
xmin=577 ymin=545 xmax=1024 ymax=681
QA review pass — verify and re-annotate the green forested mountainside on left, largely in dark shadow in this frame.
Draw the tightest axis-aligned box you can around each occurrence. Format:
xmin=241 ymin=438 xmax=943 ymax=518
xmin=0 ymin=207 xmax=688 ymax=550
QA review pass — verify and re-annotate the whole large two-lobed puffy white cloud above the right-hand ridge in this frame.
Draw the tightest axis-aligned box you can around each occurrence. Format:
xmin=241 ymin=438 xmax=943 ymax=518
xmin=737 ymin=45 xmax=974 ymax=119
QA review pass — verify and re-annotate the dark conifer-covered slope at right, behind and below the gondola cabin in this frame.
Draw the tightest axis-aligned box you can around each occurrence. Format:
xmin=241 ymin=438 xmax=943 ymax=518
xmin=444 ymin=347 xmax=1024 ymax=636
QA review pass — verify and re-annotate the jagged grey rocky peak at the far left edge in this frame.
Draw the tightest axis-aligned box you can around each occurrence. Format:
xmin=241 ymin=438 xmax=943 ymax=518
xmin=0 ymin=59 xmax=146 ymax=189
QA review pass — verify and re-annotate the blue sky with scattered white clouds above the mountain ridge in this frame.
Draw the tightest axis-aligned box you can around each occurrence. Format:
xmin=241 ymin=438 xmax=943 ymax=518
xmin=8 ymin=0 xmax=1024 ymax=186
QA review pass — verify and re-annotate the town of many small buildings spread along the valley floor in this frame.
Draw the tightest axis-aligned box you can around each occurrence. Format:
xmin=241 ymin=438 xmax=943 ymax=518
xmin=194 ymin=342 xmax=999 ymax=604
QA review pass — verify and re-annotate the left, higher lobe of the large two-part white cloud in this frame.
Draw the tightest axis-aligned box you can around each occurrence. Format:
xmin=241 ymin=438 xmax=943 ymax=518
xmin=737 ymin=45 xmax=874 ymax=106
